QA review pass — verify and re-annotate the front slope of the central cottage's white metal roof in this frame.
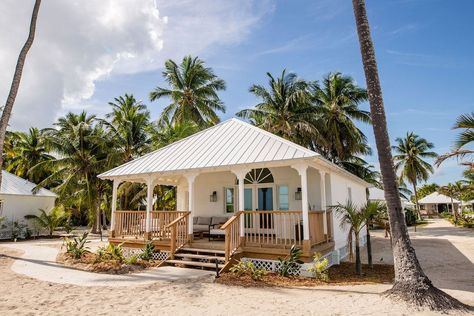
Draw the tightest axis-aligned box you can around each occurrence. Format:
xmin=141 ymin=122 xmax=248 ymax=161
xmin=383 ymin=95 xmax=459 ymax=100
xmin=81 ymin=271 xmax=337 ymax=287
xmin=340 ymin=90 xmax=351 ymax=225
xmin=99 ymin=118 xmax=320 ymax=178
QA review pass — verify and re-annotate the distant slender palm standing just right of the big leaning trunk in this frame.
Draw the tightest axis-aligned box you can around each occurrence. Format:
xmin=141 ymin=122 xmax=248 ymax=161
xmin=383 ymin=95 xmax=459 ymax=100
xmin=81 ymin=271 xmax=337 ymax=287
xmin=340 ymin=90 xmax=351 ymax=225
xmin=392 ymin=132 xmax=438 ymax=218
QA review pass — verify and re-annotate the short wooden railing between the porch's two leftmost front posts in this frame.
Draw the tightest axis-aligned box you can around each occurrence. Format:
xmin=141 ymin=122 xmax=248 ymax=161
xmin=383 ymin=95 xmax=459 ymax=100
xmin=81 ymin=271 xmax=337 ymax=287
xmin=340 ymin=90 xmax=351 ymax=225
xmin=114 ymin=211 xmax=146 ymax=239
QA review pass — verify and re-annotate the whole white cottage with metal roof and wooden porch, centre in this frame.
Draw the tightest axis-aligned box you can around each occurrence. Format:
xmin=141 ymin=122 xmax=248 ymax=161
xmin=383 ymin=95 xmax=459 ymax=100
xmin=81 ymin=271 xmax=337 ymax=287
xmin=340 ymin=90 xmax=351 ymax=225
xmin=100 ymin=119 xmax=369 ymax=266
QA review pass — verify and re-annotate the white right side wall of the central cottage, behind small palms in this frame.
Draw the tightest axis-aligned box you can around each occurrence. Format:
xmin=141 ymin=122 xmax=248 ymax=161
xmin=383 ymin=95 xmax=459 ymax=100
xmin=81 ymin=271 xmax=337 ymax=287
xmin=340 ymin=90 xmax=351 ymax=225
xmin=328 ymin=173 xmax=367 ymax=249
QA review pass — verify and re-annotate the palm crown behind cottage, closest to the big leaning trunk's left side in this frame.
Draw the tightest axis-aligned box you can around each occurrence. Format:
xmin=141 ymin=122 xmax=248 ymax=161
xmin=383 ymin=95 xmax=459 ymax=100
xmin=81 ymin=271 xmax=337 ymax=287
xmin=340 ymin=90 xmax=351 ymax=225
xmin=313 ymin=73 xmax=371 ymax=162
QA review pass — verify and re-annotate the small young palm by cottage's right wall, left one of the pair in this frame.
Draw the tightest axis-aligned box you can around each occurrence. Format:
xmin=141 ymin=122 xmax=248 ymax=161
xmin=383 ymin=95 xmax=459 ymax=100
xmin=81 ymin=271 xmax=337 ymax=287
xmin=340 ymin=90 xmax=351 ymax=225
xmin=331 ymin=201 xmax=365 ymax=275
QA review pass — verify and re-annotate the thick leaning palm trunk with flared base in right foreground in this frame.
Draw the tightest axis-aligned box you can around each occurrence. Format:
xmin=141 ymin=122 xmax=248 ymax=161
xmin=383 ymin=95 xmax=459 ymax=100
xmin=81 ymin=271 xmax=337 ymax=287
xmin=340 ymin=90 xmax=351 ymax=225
xmin=352 ymin=0 xmax=467 ymax=311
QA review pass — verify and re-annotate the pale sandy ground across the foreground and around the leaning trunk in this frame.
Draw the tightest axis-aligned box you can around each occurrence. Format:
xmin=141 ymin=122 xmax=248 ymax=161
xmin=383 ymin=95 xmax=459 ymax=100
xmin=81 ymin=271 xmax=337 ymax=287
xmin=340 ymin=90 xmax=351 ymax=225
xmin=0 ymin=221 xmax=474 ymax=315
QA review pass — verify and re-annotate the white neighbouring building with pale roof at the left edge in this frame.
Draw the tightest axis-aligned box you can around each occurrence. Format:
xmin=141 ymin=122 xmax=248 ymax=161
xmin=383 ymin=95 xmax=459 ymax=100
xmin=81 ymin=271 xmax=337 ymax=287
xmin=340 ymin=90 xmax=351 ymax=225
xmin=0 ymin=170 xmax=57 ymax=238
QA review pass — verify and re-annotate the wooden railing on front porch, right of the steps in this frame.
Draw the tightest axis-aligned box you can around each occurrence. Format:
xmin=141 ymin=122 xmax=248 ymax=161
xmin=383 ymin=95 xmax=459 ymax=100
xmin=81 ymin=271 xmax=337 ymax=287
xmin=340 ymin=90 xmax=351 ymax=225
xmin=241 ymin=211 xmax=303 ymax=246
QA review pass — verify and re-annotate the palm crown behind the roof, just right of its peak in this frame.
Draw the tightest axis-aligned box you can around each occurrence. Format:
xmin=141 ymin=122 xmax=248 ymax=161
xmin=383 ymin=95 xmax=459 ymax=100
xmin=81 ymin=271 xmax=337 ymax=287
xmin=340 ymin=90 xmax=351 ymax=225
xmin=236 ymin=70 xmax=317 ymax=146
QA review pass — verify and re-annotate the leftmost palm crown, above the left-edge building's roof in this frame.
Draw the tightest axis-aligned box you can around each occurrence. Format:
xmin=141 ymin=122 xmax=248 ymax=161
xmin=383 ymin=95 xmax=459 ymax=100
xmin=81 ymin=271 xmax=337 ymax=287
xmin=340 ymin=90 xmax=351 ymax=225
xmin=5 ymin=127 xmax=53 ymax=183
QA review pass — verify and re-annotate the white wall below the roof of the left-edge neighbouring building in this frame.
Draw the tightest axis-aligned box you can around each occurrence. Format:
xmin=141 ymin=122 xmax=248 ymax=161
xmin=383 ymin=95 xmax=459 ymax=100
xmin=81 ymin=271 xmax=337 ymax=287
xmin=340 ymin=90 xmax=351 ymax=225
xmin=0 ymin=194 xmax=56 ymax=223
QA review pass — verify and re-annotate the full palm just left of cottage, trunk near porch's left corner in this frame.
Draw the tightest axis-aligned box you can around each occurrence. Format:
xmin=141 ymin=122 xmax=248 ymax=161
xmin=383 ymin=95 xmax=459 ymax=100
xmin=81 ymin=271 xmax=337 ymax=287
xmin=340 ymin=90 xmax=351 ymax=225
xmin=33 ymin=111 xmax=114 ymax=233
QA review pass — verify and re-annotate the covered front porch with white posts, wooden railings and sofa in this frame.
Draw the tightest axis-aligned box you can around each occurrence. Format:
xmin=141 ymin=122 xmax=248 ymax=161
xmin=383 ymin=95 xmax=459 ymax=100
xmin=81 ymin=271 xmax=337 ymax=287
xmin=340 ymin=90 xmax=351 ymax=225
xmin=109 ymin=160 xmax=333 ymax=262
